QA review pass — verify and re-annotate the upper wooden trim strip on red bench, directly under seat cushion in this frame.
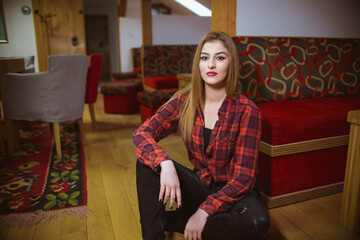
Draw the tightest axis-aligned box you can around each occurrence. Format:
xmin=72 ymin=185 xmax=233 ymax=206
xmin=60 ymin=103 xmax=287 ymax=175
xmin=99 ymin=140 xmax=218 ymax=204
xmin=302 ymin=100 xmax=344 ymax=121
xmin=259 ymin=135 xmax=349 ymax=157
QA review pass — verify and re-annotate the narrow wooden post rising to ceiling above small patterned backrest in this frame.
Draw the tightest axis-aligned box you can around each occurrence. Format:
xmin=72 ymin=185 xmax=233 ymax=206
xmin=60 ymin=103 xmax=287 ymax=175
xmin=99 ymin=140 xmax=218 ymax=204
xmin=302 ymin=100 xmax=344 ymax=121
xmin=141 ymin=0 xmax=152 ymax=46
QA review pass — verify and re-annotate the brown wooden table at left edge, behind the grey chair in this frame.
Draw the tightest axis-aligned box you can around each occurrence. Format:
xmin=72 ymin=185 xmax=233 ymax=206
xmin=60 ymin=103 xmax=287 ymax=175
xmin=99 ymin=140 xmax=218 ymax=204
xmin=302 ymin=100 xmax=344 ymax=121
xmin=0 ymin=57 xmax=25 ymax=101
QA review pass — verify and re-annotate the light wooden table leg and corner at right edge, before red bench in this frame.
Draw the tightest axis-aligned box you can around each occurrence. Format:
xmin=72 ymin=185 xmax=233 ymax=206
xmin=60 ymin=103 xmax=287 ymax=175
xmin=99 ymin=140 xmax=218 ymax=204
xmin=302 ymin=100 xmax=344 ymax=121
xmin=340 ymin=110 xmax=360 ymax=234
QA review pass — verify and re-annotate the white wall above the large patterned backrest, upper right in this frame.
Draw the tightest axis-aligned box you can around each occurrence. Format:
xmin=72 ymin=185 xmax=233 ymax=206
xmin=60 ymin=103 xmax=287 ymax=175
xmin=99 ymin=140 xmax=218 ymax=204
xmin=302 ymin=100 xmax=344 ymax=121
xmin=236 ymin=0 xmax=360 ymax=38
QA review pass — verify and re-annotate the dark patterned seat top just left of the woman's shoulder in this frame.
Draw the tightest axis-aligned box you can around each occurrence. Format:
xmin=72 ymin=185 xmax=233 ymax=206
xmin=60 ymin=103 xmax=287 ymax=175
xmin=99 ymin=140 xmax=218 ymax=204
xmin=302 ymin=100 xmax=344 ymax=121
xmin=138 ymin=89 xmax=176 ymax=109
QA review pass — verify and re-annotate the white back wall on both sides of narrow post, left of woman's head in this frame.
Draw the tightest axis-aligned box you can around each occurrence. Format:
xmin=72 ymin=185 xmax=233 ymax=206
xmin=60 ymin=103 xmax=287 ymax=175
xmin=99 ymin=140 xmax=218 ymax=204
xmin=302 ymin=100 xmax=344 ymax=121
xmin=119 ymin=0 xmax=211 ymax=72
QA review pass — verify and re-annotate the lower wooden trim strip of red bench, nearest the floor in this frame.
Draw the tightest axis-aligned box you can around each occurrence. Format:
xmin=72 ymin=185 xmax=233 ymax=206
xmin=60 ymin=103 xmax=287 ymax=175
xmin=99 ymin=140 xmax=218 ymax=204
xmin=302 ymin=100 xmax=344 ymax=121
xmin=261 ymin=182 xmax=344 ymax=208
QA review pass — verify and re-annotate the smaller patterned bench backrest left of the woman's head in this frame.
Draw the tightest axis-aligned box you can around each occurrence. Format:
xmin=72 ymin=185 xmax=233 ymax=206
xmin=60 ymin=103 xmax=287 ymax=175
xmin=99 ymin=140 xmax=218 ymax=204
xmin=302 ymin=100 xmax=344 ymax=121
xmin=143 ymin=45 xmax=197 ymax=77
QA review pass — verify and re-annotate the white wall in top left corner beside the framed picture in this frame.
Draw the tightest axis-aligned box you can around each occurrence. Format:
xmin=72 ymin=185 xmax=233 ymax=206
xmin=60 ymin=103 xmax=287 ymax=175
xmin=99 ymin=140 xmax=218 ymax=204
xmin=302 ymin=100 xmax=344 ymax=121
xmin=0 ymin=0 xmax=38 ymax=71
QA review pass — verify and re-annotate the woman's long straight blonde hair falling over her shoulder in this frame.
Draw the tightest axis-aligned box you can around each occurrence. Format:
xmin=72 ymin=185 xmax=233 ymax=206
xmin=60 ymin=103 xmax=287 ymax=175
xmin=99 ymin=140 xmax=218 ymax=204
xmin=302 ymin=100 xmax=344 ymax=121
xmin=174 ymin=31 xmax=240 ymax=142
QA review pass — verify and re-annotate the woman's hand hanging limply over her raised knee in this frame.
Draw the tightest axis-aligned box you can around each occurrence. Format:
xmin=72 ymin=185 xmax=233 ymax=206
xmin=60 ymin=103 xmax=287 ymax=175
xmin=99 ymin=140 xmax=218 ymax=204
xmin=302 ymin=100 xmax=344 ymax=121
xmin=159 ymin=160 xmax=181 ymax=208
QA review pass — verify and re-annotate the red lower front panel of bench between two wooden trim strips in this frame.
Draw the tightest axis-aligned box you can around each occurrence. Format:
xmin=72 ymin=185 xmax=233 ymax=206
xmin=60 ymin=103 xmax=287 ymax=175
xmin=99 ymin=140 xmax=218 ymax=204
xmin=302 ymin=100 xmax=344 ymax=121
xmin=259 ymin=146 xmax=347 ymax=197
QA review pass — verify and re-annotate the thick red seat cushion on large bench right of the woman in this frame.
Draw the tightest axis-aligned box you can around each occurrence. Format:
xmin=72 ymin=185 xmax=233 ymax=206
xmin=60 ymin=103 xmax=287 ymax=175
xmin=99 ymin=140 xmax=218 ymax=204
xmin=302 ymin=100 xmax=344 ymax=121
xmin=257 ymin=96 xmax=360 ymax=145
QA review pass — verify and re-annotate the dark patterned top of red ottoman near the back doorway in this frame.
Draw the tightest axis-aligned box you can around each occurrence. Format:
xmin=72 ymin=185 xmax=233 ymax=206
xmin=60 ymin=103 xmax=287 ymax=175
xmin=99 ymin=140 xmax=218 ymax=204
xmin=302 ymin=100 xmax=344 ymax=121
xmin=101 ymin=78 xmax=142 ymax=95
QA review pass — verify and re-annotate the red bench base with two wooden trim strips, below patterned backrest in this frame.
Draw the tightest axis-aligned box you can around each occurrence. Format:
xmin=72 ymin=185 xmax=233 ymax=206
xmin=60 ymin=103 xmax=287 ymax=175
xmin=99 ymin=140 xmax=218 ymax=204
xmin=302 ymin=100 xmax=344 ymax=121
xmin=257 ymin=96 xmax=360 ymax=208
